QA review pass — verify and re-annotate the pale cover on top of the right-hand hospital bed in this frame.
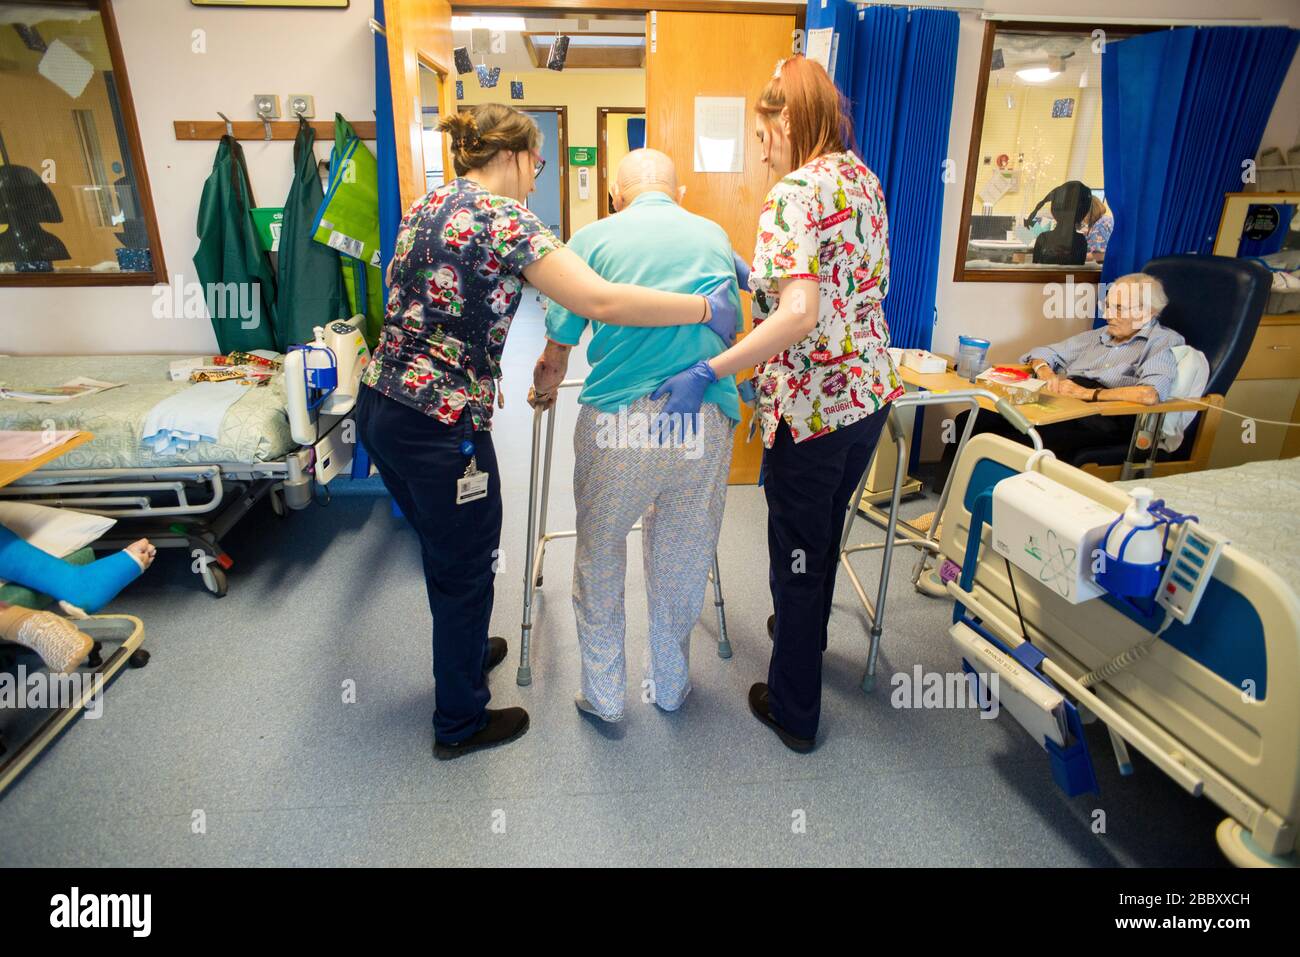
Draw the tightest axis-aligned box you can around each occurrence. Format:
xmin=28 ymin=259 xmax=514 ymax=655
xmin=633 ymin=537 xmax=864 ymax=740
xmin=1115 ymin=458 xmax=1300 ymax=594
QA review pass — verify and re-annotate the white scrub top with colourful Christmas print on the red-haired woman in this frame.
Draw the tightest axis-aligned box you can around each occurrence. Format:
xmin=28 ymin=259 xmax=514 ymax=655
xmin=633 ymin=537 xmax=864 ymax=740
xmin=749 ymin=152 xmax=904 ymax=449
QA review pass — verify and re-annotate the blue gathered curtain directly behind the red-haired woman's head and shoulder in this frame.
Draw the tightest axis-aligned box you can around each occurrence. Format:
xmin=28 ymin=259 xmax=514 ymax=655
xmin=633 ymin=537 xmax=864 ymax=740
xmin=807 ymin=0 xmax=958 ymax=348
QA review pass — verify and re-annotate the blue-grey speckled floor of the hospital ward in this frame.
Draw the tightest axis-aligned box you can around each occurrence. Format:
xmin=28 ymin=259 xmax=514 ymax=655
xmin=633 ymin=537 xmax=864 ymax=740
xmin=0 ymin=302 xmax=1222 ymax=866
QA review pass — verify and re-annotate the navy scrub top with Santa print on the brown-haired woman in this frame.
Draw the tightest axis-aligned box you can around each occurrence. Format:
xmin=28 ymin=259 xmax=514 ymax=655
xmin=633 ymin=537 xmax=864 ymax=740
xmin=361 ymin=179 xmax=562 ymax=429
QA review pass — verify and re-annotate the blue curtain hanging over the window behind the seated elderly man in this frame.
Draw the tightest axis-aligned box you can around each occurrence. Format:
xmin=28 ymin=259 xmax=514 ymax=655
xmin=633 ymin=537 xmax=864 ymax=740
xmin=1101 ymin=26 xmax=1300 ymax=281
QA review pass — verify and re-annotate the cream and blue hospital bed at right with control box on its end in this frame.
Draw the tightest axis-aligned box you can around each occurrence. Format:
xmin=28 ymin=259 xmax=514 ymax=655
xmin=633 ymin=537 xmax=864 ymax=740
xmin=940 ymin=436 xmax=1300 ymax=866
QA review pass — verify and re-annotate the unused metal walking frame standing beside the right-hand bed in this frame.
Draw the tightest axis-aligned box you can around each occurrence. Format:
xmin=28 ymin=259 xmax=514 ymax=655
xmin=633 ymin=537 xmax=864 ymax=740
xmin=840 ymin=389 xmax=1043 ymax=693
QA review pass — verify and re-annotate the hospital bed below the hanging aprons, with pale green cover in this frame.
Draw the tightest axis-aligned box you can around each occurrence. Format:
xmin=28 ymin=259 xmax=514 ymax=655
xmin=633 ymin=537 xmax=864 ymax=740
xmin=0 ymin=355 xmax=352 ymax=597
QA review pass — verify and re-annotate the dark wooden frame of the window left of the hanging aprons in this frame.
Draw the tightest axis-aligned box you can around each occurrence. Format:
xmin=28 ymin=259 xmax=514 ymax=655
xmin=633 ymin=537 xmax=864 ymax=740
xmin=0 ymin=0 xmax=168 ymax=289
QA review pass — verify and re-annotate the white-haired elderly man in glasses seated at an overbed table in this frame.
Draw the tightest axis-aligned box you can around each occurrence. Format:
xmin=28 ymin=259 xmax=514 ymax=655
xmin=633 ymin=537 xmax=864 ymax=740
xmin=935 ymin=273 xmax=1183 ymax=490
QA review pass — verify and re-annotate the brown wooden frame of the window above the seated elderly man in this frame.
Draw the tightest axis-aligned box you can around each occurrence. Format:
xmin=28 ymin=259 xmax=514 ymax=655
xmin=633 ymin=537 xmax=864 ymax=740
xmin=953 ymin=20 xmax=1170 ymax=285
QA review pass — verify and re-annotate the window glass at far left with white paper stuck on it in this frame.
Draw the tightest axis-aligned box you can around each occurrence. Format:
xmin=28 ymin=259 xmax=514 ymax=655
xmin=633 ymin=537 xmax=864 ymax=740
xmin=0 ymin=7 xmax=153 ymax=274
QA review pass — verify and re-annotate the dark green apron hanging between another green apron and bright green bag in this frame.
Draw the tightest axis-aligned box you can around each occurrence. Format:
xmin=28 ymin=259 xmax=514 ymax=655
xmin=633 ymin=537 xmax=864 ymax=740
xmin=276 ymin=117 xmax=348 ymax=352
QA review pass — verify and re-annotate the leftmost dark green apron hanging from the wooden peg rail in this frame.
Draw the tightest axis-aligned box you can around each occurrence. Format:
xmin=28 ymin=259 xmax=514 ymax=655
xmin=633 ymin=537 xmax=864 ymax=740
xmin=194 ymin=137 xmax=276 ymax=352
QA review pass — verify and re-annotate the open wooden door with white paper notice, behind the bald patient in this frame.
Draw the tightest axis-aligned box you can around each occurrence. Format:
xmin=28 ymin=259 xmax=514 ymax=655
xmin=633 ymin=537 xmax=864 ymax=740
xmin=646 ymin=12 xmax=796 ymax=485
